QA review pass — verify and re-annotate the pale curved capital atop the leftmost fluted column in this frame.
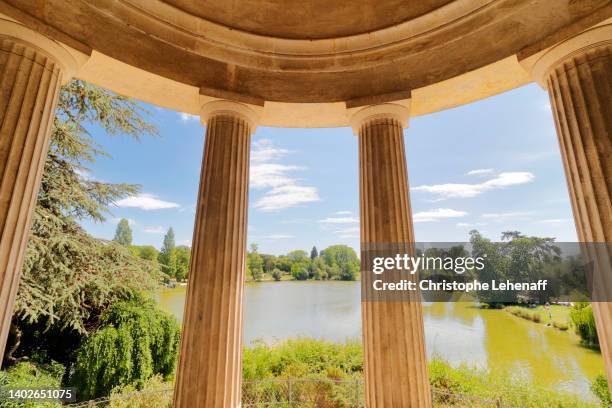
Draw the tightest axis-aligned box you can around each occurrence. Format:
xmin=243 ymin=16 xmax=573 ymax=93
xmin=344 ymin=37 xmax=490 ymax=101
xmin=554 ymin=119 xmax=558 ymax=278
xmin=0 ymin=15 xmax=89 ymax=84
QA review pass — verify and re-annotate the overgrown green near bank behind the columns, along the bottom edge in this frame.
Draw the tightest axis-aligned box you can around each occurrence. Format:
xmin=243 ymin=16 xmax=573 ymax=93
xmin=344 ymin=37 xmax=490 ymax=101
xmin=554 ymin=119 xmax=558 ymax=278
xmin=37 ymin=338 xmax=603 ymax=408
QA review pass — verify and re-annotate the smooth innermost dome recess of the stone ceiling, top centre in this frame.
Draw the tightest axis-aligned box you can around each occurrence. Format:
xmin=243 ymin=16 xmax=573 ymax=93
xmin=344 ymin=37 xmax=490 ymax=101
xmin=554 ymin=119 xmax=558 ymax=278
xmin=160 ymin=0 xmax=453 ymax=39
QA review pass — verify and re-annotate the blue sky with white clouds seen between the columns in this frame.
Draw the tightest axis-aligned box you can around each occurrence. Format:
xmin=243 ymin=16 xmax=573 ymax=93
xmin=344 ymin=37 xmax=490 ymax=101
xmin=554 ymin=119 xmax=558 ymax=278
xmin=83 ymin=84 xmax=577 ymax=254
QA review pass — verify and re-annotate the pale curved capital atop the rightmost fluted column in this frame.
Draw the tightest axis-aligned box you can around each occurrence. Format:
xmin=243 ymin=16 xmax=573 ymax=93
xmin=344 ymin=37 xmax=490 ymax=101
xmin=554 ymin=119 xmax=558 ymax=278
xmin=520 ymin=19 xmax=612 ymax=88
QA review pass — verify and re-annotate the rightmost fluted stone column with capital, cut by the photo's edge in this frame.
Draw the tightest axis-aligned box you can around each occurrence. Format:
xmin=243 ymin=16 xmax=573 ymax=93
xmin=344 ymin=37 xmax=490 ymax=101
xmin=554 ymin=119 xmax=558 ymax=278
xmin=532 ymin=24 xmax=612 ymax=390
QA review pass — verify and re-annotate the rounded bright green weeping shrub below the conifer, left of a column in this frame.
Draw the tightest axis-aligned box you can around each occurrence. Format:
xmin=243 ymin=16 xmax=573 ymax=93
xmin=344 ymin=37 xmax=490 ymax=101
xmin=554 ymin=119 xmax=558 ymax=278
xmin=72 ymin=297 xmax=180 ymax=399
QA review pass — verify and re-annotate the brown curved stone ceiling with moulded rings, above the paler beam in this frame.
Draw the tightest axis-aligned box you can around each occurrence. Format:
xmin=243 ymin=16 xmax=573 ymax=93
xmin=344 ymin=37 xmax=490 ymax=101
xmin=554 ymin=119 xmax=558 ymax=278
xmin=0 ymin=0 xmax=612 ymax=106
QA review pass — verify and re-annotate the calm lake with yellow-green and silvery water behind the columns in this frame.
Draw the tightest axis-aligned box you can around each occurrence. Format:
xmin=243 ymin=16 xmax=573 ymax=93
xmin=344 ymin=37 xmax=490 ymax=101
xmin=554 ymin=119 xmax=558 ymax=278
xmin=159 ymin=281 xmax=604 ymax=398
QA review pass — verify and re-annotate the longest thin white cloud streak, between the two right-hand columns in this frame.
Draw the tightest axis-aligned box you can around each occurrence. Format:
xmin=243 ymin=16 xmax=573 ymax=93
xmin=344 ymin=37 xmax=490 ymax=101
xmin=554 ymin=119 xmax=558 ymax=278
xmin=412 ymin=171 xmax=535 ymax=198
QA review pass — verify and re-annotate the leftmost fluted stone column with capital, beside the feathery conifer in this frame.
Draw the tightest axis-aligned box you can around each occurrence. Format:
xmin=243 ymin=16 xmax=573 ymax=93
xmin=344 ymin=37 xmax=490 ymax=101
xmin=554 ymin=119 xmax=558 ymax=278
xmin=0 ymin=19 xmax=77 ymax=355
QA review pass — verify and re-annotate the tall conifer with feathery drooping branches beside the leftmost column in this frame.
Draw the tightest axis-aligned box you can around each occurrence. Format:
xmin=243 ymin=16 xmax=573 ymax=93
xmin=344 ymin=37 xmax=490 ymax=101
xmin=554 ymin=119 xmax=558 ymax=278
xmin=5 ymin=81 xmax=156 ymax=363
